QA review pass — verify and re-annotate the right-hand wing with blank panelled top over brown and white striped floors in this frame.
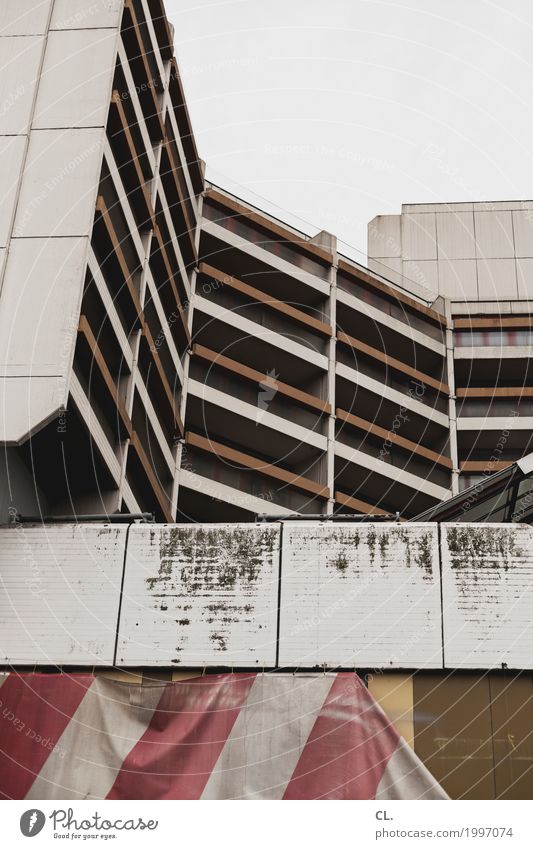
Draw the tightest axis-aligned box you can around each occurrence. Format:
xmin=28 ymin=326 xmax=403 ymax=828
xmin=368 ymin=201 xmax=533 ymax=489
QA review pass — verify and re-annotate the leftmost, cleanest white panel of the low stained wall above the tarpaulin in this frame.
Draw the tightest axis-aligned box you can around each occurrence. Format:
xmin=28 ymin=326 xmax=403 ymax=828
xmin=0 ymin=525 xmax=126 ymax=666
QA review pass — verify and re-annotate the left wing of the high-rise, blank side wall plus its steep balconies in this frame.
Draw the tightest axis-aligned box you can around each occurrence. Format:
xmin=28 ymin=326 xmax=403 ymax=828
xmin=0 ymin=0 xmax=204 ymax=520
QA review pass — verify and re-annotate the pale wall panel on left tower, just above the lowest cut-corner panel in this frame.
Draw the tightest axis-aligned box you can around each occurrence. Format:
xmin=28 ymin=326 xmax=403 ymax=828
xmin=0 ymin=239 xmax=87 ymax=375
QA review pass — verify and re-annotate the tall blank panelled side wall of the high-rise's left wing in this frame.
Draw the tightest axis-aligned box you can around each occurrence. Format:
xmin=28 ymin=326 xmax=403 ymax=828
xmin=0 ymin=0 xmax=121 ymax=444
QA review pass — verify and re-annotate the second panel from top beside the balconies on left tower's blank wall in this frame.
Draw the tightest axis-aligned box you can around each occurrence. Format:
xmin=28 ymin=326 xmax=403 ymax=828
xmin=32 ymin=29 xmax=117 ymax=129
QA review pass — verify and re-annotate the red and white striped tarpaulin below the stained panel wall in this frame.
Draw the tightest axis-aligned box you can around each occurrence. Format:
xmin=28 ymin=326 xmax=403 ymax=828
xmin=0 ymin=673 xmax=447 ymax=799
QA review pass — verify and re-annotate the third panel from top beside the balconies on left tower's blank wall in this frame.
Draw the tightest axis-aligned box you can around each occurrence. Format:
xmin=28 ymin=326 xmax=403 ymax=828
xmin=14 ymin=129 xmax=104 ymax=237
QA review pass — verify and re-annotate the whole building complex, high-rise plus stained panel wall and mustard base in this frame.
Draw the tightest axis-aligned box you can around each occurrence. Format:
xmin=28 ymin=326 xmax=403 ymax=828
xmin=0 ymin=0 xmax=533 ymax=798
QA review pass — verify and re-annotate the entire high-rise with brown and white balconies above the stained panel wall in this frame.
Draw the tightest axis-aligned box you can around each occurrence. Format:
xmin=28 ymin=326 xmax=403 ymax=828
xmin=0 ymin=0 xmax=533 ymax=521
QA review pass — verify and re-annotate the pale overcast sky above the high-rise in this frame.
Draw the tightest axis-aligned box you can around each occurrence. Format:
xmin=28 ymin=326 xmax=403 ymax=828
xmin=166 ymin=0 xmax=533 ymax=253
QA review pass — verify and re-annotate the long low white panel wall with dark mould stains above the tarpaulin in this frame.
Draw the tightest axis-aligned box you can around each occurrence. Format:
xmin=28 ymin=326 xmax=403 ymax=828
xmin=0 ymin=521 xmax=533 ymax=670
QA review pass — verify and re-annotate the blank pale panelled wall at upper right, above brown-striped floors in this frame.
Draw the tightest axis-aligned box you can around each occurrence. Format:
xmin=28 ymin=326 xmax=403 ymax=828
xmin=368 ymin=201 xmax=533 ymax=300
